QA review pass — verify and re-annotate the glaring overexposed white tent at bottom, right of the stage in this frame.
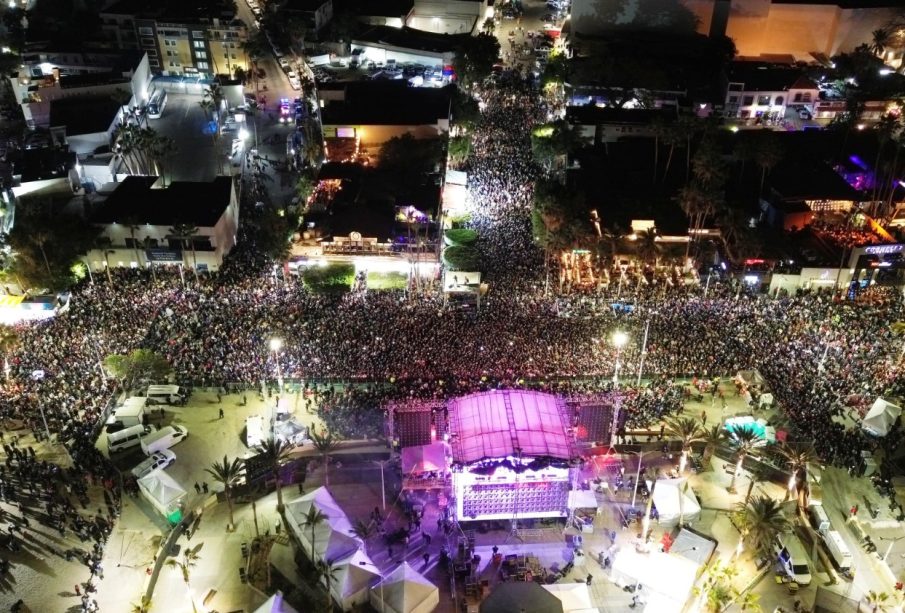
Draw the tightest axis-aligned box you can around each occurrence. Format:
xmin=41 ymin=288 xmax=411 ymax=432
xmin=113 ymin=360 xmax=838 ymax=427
xmin=610 ymin=547 xmax=699 ymax=613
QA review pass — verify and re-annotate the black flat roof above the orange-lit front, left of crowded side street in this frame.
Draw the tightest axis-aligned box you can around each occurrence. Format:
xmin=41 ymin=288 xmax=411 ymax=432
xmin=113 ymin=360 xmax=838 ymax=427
xmin=321 ymin=81 xmax=449 ymax=126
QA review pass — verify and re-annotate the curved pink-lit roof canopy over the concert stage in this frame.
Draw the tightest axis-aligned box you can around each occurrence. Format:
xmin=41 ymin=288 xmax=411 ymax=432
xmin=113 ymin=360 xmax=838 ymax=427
xmin=449 ymin=390 xmax=571 ymax=464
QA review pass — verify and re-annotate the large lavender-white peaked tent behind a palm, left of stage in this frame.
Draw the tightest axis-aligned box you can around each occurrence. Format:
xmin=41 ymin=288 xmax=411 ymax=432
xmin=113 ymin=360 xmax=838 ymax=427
xmin=286 ymin=487 xmax=361 ymax=562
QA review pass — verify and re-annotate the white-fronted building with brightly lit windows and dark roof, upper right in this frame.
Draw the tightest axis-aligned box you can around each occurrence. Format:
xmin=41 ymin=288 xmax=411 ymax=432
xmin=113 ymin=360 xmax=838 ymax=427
xmin=723 ymin=62 xmax=820 ymax=121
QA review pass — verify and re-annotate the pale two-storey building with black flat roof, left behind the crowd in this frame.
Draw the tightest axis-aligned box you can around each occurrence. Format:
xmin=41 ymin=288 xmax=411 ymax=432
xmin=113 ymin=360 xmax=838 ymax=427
xmin=85 ymin=176 xmax=239 ymax=273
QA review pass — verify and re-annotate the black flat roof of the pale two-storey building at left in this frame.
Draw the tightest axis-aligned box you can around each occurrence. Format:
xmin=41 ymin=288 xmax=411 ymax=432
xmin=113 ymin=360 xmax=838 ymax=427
xmin=91 ymin=176 xmax=232 ymax=228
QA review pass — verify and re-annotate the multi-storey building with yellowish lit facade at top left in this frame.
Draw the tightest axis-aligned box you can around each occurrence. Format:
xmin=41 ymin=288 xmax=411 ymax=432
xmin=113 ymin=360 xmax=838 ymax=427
xmin=100 ymin=0 xmax=249 ymax=77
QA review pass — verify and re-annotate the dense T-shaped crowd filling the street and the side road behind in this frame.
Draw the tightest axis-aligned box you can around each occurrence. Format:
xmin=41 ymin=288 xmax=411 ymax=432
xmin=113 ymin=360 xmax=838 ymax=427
xmin=0 ymin=70 xmax=905 ymax=607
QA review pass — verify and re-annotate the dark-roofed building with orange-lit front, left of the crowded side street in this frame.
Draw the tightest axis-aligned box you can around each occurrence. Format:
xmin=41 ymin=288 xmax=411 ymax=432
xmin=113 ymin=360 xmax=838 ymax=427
xmin=318 ymin=81 xmax=450 ymax=161
